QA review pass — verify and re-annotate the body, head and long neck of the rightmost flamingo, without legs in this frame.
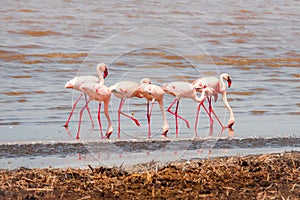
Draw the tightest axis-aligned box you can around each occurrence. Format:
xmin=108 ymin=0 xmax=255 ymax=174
xmin=192 ymin=73 xmax=235 ymax=128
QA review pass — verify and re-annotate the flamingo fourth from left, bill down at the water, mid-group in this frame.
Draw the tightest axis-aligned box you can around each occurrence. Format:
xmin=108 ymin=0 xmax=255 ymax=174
xmin=140 ymin=78 xmax=169 ymax=138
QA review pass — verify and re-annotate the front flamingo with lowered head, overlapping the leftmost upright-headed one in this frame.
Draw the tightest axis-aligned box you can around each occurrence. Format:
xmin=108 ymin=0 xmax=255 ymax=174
xmin=76 ymin=82 xmax=113 ymax=139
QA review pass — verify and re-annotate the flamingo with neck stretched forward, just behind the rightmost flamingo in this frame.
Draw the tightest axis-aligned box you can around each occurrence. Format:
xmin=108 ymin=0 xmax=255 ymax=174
xmin=163 ymin=81 xmax=215 ymax=137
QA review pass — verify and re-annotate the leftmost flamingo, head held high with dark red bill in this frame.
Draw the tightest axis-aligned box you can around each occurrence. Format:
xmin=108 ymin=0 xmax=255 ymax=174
xmin=64 ymin=63 xmax=108 ymax=128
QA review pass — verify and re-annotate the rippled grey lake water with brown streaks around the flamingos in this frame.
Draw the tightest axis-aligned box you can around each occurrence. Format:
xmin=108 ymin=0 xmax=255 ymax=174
xmin=0 ymin=0 xmax=300 ymax=168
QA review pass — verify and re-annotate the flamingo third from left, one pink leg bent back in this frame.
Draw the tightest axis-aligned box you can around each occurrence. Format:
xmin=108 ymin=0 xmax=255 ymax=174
xmin=106 ymin=81 xmax=144 ymax=138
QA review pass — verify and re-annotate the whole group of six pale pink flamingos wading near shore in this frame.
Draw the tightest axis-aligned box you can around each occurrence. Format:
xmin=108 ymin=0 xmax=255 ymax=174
xmin=64 ymin=63 xmax=235 ymax=139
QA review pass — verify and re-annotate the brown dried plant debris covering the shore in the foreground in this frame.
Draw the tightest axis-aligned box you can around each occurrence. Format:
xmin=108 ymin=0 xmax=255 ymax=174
xmin=0 ymin=151 xmax=300 ymax=200
